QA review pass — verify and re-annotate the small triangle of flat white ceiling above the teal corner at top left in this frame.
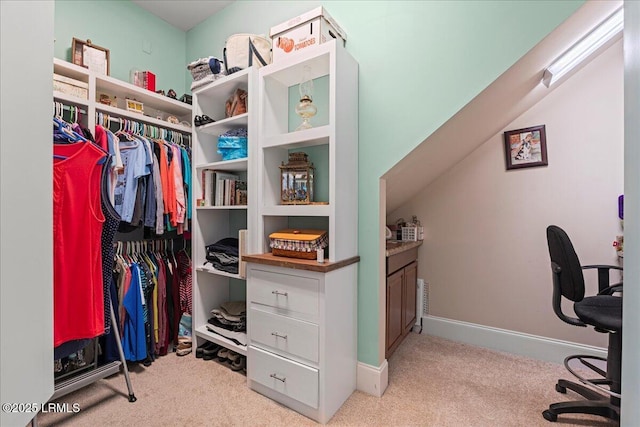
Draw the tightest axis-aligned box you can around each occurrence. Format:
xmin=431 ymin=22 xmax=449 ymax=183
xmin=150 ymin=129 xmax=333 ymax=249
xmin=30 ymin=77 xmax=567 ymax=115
xmin=132 ymin=0 xmax=233 ymax=31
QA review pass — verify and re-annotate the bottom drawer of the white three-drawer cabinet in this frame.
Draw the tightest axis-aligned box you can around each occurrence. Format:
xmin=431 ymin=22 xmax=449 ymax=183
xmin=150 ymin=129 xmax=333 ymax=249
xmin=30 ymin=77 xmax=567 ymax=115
xmin=247 ymin=346 xmax=318 ymax=408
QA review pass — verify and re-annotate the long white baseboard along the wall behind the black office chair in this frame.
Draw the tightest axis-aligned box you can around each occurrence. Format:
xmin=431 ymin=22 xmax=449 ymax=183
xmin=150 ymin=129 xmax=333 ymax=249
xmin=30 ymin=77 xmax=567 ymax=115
xmin=422 ymin=316 xmax=607 ymax=363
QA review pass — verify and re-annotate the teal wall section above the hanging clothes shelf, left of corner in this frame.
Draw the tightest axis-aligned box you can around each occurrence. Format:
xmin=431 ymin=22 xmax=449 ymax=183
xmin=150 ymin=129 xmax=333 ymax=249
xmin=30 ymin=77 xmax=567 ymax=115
xmin=54 ymin=0 xmax=187 ymax=97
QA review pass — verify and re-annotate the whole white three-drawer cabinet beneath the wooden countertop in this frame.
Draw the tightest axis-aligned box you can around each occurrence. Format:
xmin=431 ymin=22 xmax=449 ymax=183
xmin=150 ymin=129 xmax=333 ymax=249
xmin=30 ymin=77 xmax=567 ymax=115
xmin=245 ymin=256 xmax=358 ymax=423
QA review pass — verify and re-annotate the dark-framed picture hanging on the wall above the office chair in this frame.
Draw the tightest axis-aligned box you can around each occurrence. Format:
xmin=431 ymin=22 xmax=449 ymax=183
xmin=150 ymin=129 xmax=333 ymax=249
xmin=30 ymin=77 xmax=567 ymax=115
xmin=504 ymin=125 xmax=549 ymax=170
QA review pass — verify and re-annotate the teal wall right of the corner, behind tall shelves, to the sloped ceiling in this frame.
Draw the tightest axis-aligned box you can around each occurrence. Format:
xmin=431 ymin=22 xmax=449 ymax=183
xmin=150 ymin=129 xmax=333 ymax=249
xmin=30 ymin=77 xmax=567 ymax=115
xmin=187 ymin=0 xmax=583 ymax=366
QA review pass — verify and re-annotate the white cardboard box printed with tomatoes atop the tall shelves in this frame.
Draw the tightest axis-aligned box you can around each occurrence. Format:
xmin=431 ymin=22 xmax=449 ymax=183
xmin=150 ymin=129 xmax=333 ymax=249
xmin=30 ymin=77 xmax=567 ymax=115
xmin=269 ymin=7 xmax=347 ymax=62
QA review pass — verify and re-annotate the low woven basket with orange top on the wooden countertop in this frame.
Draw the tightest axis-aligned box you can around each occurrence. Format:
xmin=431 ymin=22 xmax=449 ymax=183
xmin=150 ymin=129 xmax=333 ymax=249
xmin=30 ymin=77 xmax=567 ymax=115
xmin=269 ymin=229 xmax=329 ymax=259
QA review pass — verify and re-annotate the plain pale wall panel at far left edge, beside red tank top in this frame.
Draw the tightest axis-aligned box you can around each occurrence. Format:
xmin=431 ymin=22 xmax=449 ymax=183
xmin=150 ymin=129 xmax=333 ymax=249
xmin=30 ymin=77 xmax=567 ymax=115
xmin=0 ymin=1 xmax=54 ymax=426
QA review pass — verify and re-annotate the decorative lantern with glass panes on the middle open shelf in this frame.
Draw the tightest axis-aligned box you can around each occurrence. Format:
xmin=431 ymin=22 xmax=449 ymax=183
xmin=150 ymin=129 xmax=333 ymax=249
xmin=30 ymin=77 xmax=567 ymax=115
xmin=280 ymin=152 xmax=315 ymax=205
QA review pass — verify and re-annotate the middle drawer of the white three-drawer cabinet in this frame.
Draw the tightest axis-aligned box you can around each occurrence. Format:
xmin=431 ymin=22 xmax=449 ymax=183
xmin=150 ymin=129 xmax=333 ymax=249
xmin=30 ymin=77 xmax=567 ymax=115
xmin=250 ymin=307 xmax=320 ymax=363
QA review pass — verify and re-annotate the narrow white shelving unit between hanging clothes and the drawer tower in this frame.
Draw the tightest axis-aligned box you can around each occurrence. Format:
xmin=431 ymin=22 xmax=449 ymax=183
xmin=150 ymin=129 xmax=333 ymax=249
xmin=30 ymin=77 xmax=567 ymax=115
xmin=192 ymin=68 xmax=257 ymax=355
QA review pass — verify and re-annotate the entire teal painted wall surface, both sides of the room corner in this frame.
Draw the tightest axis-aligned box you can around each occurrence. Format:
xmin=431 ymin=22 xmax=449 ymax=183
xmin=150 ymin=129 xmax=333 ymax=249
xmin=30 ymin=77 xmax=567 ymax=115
xmin=54 ymin=0 xmax=583 ymax=366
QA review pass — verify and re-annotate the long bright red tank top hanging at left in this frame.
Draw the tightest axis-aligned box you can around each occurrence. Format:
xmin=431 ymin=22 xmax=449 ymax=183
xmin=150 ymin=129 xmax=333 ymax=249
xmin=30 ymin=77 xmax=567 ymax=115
xmin=53 ymin=142 xmax=105 ymax=347
